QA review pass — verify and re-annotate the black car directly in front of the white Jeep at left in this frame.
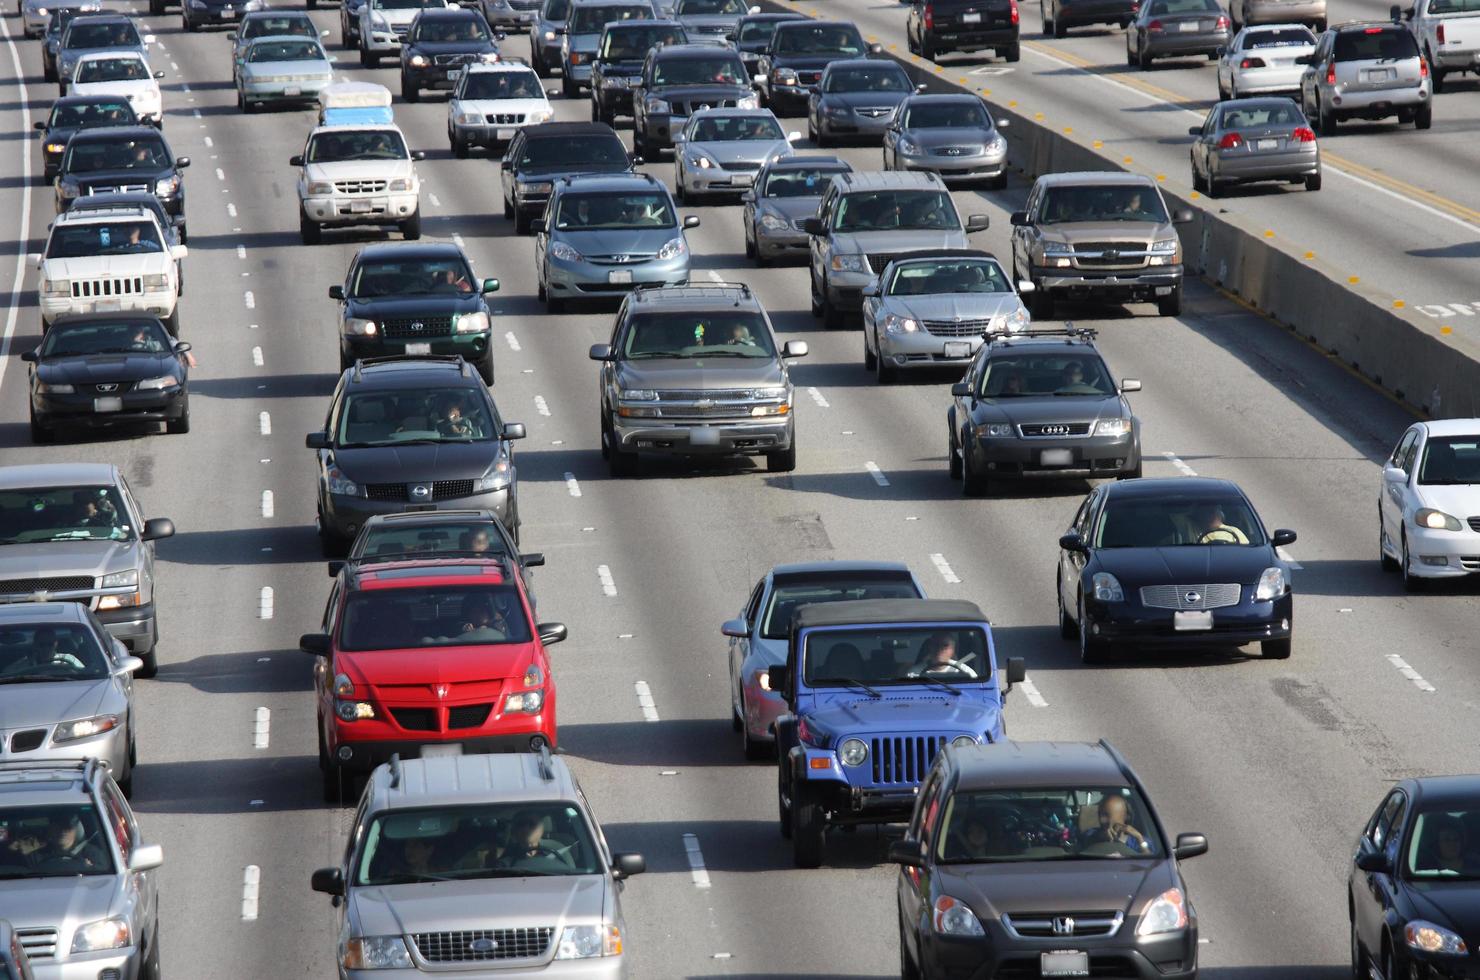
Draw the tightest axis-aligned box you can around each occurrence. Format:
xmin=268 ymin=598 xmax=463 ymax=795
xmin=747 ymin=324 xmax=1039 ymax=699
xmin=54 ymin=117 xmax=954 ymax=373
xmin=21 ymin=314 xmax=189 ymax=443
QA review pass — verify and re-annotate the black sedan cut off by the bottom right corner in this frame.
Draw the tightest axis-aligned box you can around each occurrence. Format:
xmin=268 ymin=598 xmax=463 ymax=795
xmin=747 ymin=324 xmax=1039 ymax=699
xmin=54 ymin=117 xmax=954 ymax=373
xmin=1347 ymin=776 xmax=1480 ymax=980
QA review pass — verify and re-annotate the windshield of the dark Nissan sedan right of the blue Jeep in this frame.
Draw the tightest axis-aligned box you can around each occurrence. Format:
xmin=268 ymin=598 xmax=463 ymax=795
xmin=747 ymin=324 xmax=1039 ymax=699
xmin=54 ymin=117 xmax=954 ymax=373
xmin=1092 ymin=491 xmax=1264 ymax=548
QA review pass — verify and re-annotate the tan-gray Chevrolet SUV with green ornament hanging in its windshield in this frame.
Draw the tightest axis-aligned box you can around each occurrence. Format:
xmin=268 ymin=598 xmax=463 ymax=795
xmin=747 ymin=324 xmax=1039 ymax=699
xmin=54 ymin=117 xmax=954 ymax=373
xmin=591 ymin=283 xmax=807 ymax=477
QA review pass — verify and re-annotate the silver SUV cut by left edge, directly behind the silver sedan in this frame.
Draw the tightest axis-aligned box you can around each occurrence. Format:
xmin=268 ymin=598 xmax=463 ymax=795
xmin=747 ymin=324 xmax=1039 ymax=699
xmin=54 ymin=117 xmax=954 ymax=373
xmin=0 ymin=463 xmax=175 ymax=677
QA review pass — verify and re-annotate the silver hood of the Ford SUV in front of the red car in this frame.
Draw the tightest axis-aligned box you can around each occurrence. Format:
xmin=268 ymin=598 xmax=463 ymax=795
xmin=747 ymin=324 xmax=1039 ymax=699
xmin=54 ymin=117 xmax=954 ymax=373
xmin=351 ymin=875 xmax=608 ymax=939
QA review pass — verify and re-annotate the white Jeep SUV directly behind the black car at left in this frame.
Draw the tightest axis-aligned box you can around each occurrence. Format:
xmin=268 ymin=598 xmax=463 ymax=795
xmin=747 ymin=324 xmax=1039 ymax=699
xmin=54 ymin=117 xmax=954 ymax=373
xmin=33 ymin=206 xmax=186 ymax=336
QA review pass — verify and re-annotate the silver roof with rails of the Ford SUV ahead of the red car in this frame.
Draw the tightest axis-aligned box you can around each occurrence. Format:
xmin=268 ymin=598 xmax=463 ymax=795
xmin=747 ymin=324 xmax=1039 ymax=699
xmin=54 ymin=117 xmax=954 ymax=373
xmin=369 ymin=752 xmax=580 ymax=813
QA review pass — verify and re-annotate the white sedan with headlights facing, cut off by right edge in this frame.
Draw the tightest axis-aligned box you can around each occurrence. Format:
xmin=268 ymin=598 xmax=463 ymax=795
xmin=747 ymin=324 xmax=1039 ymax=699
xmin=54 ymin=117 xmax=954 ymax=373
xmin=1378 ymin=419 xmax=1480 ymax=592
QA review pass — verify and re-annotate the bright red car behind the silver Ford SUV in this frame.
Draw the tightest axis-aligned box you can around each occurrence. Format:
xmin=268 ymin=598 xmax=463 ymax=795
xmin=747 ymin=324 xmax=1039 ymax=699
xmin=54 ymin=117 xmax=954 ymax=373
xmin=299 ymin=557 xmax=565 ymax=802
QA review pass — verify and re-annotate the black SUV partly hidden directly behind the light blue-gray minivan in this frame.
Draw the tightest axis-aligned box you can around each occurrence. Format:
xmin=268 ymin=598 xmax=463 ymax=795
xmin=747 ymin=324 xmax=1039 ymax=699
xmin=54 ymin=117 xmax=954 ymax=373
xmin=499 ymin=123 xmax=642 ymax=235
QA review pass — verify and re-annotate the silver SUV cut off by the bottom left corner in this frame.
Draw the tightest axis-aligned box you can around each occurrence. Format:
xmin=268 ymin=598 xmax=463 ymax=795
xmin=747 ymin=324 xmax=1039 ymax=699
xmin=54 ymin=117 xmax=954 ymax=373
xmin=0 ymin=759 xmax=164 ymax=980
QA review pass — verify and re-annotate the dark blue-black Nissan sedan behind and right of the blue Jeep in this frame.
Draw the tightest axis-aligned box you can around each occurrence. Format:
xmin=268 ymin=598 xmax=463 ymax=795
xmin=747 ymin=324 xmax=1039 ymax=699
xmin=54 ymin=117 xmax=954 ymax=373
xmin=1057 ymin=477 xmax=1295 ymax=663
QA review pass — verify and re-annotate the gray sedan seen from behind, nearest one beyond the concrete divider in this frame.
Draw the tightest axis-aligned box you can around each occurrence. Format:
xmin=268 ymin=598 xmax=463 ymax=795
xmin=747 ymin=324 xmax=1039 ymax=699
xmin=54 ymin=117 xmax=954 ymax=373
xmin=1187 ymin=98 xmax=1320 ymax=197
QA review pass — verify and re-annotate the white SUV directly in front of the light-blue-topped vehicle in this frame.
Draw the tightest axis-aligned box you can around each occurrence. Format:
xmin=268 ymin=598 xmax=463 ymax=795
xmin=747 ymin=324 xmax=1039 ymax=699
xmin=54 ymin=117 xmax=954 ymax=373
xmin=289 ymin=126 xmax=426 ymax=244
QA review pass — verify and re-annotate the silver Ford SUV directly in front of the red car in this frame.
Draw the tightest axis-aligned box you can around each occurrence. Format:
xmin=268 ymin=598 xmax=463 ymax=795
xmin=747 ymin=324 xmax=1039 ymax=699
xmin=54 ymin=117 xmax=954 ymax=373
xmin=312 ymin=751 xmax=645 ymax=980
